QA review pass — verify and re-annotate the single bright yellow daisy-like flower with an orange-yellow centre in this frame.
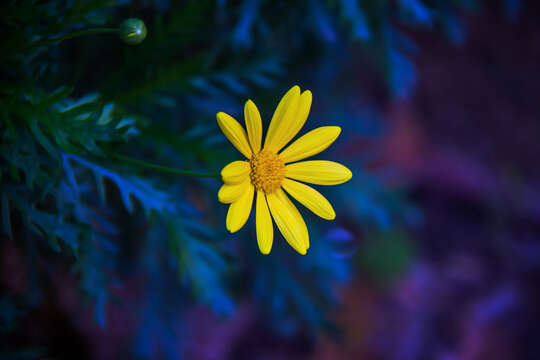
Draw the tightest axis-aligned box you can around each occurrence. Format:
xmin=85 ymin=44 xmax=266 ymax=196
xmin=216 ymin=86 xmax=352 ymax=255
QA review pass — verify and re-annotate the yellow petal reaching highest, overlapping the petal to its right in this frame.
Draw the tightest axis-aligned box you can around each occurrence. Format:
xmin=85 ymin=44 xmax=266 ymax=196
xmin=264 ymin=85 xmax=305 ymax=152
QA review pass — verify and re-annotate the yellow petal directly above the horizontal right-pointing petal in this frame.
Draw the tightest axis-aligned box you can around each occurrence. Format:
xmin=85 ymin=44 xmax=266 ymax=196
xmin=279 ymin=126 xmax=341 ymax=163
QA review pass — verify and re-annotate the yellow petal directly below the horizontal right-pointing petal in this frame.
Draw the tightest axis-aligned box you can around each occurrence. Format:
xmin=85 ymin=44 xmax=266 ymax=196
xmin=281 ymin=179 xmax=336 ymax=220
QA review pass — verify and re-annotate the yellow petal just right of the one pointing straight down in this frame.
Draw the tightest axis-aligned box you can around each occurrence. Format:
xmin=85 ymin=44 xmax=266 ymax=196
xmin=266 ymin=189 xmax=309 ymax=255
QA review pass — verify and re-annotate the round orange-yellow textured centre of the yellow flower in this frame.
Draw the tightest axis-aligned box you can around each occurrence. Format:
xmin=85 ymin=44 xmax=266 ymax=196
xmin=249 ymin=150 xmax=285 ymax=194
